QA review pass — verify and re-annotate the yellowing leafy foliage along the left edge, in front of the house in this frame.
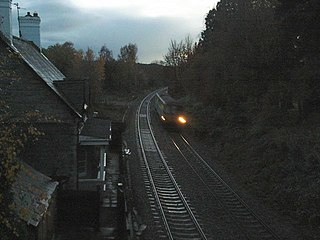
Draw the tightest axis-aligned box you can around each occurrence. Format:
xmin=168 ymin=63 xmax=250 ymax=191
xmin=0 ymin=101 xmax=42 ymax=240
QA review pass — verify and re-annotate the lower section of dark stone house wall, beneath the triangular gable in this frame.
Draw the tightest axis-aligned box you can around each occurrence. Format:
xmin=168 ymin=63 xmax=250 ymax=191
xmin=21 ymin=123 xmax=77 ymax=188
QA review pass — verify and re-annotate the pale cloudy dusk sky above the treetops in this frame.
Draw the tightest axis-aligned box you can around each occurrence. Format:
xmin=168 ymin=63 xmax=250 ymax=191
xmin=12 ymin=0 xmax=218 ymax=63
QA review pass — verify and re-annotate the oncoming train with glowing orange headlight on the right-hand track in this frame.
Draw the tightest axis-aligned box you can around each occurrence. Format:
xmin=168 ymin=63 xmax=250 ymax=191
xmin=154 ymin=90 xmax=188 ymax=129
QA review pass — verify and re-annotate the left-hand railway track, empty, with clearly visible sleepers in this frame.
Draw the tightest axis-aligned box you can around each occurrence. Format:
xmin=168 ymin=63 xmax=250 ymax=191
xmin=136 ymin=92 xmax=207 ymax=240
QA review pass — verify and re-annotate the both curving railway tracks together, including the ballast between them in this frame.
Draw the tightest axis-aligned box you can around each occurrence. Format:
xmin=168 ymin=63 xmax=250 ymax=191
xmin=136 ymin=92 xmax=281 ymax=240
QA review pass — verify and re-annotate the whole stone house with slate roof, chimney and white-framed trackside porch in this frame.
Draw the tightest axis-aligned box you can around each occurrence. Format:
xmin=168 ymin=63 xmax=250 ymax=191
xmin=0 ymin=0 xmax=119 ymax=236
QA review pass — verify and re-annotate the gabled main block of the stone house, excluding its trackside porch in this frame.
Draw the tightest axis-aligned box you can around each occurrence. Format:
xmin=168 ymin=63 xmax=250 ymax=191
xmin=0 ymin=0 xmax=88 ymax=189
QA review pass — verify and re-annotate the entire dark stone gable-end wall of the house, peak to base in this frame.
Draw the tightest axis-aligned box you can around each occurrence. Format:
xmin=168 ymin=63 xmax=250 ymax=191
xmin=0 ymin=39 xmax=80 ymax=188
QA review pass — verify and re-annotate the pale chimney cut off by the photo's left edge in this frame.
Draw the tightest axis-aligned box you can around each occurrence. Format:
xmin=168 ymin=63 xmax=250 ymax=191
xmin=0 ymin=0 xmax=12 ymax=42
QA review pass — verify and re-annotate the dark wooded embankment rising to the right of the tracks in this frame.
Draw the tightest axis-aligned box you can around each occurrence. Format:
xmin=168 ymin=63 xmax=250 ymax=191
xmin=167 ymin=0 xmax=320 ymax=239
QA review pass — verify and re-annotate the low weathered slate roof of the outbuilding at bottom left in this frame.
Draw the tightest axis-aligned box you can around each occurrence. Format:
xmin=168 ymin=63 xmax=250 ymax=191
xmin=12 ymin=163 xmax=58 ymax=227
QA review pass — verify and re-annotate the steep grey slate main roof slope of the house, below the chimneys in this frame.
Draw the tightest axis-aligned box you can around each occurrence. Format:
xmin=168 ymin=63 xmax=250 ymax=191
xmin=10 ymin=36 xmax=81 ymax=118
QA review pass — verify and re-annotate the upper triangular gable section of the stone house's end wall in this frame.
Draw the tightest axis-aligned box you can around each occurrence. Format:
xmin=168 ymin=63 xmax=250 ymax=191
xmin=0 ymin=40 xmax=75 ymax=122
